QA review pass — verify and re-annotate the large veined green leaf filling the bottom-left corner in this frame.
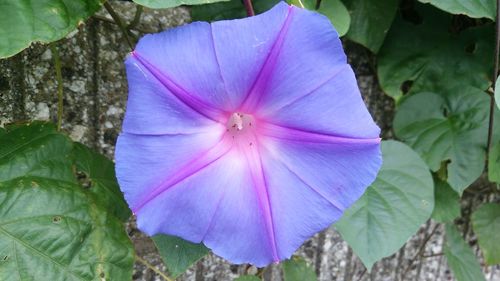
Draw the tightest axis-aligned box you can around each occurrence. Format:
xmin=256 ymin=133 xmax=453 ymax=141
xmin=0 ymin=177 xmax=134 ymax=281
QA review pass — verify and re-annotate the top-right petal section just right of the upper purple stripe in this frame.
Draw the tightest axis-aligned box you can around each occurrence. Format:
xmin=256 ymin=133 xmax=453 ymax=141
xmin=243 ymin=6 xmax=347 ymax=115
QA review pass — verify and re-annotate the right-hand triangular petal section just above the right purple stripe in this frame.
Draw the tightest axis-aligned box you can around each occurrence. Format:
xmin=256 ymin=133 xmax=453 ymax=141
xmin=262 ymin=67 xmax=380 ymax=138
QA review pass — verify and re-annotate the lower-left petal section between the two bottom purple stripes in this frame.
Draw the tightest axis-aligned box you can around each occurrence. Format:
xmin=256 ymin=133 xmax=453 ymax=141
xmin=136 ymin=150 xmax=275 ymax=266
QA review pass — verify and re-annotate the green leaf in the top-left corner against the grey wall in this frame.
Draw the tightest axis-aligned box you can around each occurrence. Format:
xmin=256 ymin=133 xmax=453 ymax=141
xmin=0 ymin=0 xmax=101 ymax=58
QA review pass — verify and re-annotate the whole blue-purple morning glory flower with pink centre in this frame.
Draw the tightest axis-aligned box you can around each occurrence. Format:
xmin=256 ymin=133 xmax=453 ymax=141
xmin=116 ymin=3 xmax=381 ymax=266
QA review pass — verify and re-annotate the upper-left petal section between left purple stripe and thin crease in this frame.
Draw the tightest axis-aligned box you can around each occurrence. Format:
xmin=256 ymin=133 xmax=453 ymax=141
xmin=132 ymin=22 xmax=228 ymax=119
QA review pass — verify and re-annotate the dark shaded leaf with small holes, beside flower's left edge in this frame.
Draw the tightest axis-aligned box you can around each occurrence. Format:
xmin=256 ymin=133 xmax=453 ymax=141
xmin=73 ymin=143 xmax=130 ymax=221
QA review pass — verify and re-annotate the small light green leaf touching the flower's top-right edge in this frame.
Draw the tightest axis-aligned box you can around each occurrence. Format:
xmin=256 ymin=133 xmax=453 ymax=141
xmin=287 ymin=0 xmax=351 ymax=36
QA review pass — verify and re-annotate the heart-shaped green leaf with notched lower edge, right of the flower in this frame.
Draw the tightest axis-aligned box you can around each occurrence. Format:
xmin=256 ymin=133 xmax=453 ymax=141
xmin=394 ymin=87 xmax=489 ymax=194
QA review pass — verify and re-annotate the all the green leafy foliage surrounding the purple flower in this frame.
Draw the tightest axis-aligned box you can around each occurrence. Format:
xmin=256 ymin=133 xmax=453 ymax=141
xmin=0 ymin=0 xmax=500 ymax=281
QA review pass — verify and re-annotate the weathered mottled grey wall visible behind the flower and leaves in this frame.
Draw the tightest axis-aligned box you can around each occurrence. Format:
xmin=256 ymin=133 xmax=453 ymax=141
xmin=0 ymin=1 xmax=500 ymax=281
